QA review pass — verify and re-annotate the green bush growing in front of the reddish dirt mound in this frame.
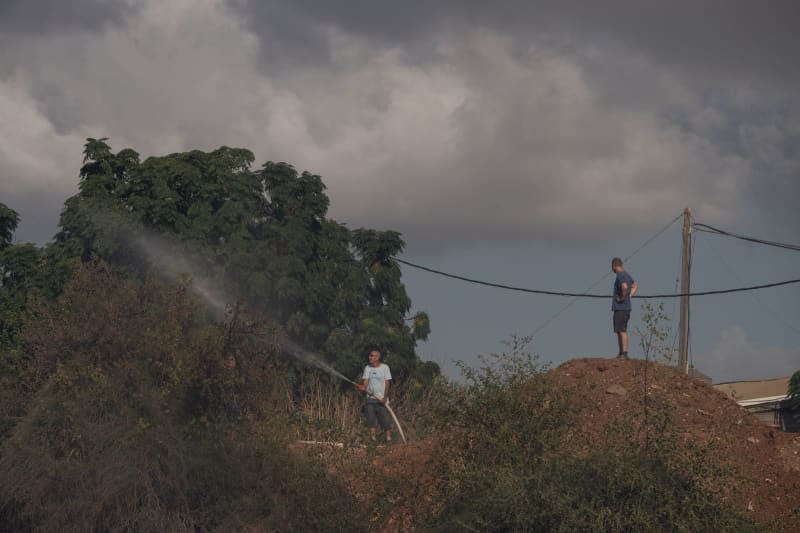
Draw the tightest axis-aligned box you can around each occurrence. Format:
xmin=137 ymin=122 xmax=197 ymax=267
xmin=426 ymin=338 xmax=756 ymax=531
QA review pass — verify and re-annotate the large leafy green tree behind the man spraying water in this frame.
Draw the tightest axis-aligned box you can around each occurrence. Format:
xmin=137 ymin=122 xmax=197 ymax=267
xmin=53 ymin=139 xmax=429 ymax=378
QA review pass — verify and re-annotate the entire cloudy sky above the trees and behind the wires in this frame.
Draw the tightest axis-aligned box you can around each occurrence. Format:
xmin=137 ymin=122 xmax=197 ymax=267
xmin=0 ymin=0 xmax=800 ymax=381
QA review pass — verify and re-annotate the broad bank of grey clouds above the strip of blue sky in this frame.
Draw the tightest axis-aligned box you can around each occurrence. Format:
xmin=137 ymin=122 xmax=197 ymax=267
xmin=0 ymin=0 xmax=800 ymax=243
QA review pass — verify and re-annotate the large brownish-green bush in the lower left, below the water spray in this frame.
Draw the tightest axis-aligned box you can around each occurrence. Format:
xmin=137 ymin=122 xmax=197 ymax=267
xmin=0 ymin=264 xmax=357 ymax=531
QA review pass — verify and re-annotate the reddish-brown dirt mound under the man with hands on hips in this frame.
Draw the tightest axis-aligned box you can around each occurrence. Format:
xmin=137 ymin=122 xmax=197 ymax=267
xmin=548 ymin=359 xmax=800 ymax=531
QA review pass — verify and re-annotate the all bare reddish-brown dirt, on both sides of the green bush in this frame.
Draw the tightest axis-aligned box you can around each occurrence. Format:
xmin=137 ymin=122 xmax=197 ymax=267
xmin=316 ymin=358 xmax=800 ymax=531
